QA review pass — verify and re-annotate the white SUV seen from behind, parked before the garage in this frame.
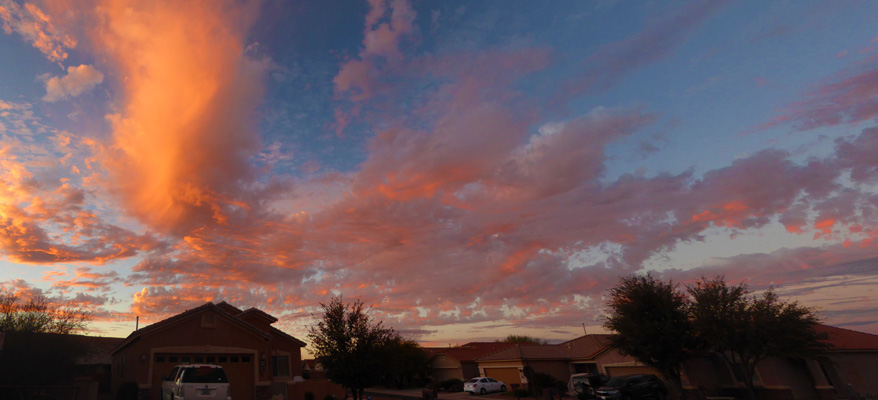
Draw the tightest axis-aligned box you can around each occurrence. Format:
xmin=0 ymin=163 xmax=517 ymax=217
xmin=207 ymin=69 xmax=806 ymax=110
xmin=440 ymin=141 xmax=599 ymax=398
xmin=162 ymin=364 xmax=232 ymax=400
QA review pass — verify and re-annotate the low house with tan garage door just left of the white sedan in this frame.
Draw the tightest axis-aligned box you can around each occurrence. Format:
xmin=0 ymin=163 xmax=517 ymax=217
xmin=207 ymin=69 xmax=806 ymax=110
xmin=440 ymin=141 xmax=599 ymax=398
xmin=425 ymin=342 xmax=515 ymax=382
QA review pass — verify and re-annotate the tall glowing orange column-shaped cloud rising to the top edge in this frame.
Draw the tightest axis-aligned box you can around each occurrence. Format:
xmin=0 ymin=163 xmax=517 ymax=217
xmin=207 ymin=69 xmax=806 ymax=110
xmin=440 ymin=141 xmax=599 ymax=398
xmin=98 ymin=0 xmax=269 ymax=233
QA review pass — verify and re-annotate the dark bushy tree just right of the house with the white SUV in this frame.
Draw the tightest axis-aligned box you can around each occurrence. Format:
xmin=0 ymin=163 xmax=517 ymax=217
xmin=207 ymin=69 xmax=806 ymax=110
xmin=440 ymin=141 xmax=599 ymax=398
xmin=308 ymin=297 xmax=397 ymax=400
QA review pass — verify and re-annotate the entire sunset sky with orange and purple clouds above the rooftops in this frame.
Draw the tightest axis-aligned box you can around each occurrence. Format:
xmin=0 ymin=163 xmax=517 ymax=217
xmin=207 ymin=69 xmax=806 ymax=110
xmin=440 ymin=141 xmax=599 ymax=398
xmin=0 ymin=0 xmax=878 ymax=345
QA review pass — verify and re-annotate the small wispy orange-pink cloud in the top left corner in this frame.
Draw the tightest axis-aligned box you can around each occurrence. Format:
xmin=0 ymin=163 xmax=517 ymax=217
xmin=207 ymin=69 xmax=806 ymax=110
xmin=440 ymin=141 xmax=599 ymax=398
xmin=0 ymin=0 xmax=76 ymax=63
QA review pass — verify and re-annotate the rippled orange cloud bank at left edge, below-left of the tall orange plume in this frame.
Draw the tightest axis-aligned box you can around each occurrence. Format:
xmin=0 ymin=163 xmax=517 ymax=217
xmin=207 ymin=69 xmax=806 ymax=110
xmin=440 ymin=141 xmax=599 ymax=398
xmin=0 ymin=97 xmax=158 ymax=264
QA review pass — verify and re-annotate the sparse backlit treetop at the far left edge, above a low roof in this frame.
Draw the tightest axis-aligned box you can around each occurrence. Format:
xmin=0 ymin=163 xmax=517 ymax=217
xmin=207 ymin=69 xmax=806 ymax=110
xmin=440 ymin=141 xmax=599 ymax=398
xmin=0 ymin=289 xmax=91 ymax=334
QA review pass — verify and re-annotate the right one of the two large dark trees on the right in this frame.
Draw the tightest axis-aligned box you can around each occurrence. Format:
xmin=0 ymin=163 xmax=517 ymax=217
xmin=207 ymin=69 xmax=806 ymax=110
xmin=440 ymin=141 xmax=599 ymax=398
xmin=688 ymin=276 xmax=827 ymax=399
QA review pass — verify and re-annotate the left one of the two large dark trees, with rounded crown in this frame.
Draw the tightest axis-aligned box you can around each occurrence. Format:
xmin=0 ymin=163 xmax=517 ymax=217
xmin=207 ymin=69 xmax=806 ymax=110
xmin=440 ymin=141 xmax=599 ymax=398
xmin=604 ymin=274 xmax=692 ymax=398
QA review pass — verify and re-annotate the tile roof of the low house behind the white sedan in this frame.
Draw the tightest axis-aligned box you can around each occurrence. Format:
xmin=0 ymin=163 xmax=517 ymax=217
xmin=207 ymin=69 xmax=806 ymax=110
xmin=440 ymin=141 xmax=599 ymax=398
xmin=478 ymin=335 xmax=610 ymax=361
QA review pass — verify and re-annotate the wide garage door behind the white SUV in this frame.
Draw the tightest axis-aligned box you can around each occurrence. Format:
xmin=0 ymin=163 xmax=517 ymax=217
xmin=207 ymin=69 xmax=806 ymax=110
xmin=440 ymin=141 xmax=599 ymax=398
xmin=150 ymin=353 xmax=256 ymax=400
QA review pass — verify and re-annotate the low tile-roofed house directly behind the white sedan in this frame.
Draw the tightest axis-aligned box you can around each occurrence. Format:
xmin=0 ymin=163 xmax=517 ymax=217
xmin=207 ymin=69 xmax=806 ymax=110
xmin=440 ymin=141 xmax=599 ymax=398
xmin=476 ymin=335 xmax=653 ymax=387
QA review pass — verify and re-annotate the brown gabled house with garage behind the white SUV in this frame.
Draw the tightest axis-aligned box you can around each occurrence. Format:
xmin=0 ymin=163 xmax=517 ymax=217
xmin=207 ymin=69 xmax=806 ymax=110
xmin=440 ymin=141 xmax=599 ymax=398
xmin=110 ymin=302 xmax=305 ymax=400
